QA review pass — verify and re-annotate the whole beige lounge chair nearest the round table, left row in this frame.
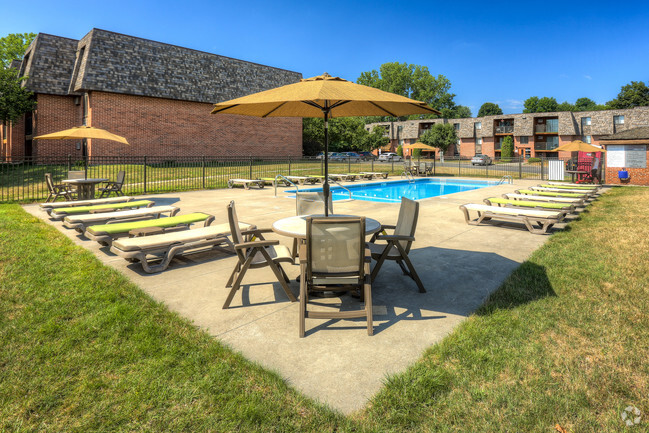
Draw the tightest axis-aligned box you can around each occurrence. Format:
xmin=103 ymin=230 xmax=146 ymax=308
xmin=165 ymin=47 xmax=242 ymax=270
xmin=110 ymin=223 xmax=255 ymax=274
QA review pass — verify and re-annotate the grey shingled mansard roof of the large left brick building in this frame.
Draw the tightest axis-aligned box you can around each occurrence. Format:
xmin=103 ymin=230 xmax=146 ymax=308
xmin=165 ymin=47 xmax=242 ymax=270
xmin=21 ymin=29 xmax=302 ymax=103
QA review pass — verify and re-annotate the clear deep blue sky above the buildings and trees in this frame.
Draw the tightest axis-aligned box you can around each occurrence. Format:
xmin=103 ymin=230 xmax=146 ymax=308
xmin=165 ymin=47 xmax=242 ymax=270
xmin=5 ymin=0 xmax=649 ymax=115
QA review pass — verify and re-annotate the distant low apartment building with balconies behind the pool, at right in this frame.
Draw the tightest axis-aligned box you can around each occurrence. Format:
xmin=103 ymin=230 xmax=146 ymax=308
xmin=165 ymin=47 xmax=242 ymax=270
xmin=366 ymin=107 xmax=649 ymax=158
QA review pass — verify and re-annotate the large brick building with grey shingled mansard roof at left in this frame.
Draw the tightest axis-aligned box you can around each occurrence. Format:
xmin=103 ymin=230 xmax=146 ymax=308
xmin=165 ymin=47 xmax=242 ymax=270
xmin=0 ymin=29 xmax=302 ymax=160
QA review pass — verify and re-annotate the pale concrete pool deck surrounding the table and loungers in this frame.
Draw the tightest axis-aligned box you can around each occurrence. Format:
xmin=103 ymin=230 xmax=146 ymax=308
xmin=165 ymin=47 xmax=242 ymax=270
xmin=25 ymin=180 xmax=572 ymax=413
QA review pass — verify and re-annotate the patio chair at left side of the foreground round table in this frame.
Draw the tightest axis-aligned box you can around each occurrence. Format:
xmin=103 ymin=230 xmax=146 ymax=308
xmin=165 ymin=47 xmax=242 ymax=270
xmin=223 ymin=201 xmax=297 ymax=309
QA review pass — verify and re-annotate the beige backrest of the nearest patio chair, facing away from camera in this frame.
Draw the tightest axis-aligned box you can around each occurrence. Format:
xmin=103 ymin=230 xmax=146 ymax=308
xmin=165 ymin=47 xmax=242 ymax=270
xmin=306 ymin=217 xmax=365 ymax=284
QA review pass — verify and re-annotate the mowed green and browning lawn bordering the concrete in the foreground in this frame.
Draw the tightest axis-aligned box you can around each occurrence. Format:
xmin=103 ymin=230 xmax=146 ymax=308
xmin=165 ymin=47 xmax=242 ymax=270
xmin=0 ymin=188 xmax=649 ymax=432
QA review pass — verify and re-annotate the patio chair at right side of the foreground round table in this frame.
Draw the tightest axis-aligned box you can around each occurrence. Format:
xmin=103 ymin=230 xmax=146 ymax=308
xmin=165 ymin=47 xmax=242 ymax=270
xmin=369 ymin=197 xmax=426 ymax=293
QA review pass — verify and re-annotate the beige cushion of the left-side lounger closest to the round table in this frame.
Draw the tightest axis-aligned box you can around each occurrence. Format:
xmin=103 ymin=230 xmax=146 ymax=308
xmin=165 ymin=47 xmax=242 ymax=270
xmin=113 ymin=222 xmax=253 ymax=251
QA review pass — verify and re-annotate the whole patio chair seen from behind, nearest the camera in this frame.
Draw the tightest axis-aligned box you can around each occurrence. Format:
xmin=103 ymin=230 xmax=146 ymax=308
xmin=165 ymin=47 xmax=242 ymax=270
xmin=299 ymin=217 xmax=374 ymax=337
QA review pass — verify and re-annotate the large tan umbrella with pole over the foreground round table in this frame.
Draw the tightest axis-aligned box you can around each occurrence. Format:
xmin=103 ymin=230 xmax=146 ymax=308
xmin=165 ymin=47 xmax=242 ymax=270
xmin=212 ymin=73 xmax=440 ymax=215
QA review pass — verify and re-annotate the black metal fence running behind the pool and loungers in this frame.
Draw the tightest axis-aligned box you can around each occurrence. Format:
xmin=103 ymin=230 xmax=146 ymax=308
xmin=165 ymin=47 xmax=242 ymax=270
xmin=0 ymin=156 xmax=548 ymax=202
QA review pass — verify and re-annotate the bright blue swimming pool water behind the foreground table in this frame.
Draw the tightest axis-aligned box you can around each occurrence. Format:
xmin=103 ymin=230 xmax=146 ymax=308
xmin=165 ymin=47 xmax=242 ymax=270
xmin=287 ymin=179 xmax=497 ymax=203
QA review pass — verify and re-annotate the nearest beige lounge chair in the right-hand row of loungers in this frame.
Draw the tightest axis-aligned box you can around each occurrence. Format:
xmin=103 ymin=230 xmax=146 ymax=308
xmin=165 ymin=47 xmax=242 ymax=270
xmin=460 ymin=203 xmax=566 ymax=234
